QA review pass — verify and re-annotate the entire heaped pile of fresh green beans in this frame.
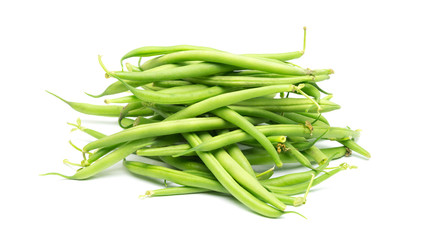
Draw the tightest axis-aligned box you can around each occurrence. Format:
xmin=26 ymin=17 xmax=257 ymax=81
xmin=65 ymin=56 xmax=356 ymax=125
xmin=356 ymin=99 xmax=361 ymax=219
xmin=43 ymin=29 xmax=370 ymax=218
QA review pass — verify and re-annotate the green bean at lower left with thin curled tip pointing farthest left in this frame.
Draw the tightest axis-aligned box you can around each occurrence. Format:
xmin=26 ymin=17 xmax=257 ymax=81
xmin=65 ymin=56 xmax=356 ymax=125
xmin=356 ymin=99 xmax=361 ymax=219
xmin=42 ymin=138 xmax=153 ymax=180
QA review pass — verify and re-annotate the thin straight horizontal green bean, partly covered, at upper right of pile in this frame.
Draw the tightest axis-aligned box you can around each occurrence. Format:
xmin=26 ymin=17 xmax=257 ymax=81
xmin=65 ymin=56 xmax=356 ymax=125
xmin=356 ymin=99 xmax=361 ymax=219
xmin=186 ymin=75 xmax=330 ymax=87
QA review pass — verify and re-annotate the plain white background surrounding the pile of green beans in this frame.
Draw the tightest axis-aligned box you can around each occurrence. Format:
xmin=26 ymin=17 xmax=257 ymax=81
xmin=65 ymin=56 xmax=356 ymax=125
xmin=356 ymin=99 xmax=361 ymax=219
xmin=0 ymin=0 xmax=428 ymax=239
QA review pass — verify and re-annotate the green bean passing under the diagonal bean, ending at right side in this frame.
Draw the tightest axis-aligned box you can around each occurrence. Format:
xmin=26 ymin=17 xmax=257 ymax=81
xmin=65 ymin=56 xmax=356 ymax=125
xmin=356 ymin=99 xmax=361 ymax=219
xmin=179 ymin=124 xmax=359 ymax=157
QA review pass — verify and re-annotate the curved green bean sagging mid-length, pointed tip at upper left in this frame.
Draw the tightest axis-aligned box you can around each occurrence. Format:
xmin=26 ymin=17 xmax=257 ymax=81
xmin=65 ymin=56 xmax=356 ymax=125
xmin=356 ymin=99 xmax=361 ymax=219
xmin=113 ymin=79 xmax=226 ymax=104
